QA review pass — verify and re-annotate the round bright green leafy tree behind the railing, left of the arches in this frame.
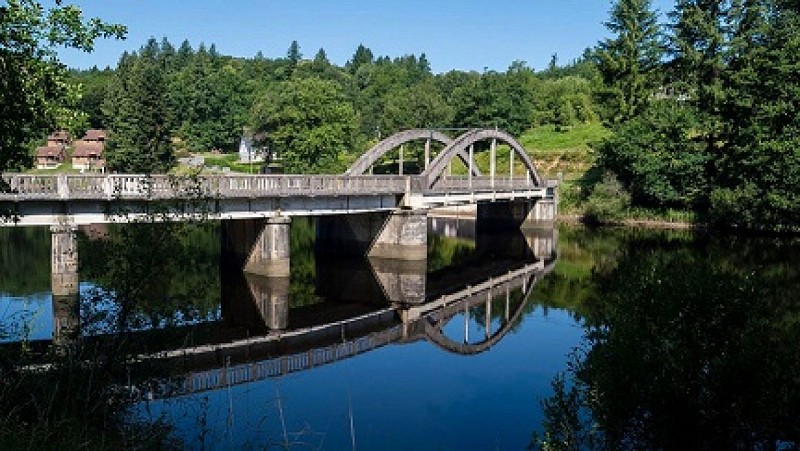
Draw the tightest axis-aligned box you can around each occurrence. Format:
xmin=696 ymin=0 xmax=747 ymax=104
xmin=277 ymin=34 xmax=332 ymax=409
xmin=251 ymin=78 xmax=358 ymax=173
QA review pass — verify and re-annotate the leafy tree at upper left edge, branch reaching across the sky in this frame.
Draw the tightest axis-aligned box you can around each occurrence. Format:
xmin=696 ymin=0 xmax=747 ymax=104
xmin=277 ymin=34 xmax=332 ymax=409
xmin=0 ymin=0 xmax=126 ymax=171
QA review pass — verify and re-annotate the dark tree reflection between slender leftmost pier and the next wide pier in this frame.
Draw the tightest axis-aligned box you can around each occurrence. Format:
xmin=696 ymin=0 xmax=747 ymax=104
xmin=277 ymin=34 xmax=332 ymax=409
xmin=79 ymin=222 xmax=220 ymax=327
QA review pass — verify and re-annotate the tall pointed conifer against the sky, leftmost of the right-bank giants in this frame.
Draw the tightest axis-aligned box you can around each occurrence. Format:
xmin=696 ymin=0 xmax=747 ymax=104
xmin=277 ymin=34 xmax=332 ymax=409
xmin=595 ymin=0 xmax=663 ymax=123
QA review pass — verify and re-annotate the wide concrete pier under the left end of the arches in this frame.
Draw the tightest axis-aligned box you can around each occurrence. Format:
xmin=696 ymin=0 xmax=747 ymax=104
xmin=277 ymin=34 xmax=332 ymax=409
xmin=317 ymin=209 xmax=428 ymax=260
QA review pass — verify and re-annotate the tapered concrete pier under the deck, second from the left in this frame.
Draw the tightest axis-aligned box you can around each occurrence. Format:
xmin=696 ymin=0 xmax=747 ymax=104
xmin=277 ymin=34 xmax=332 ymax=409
xmin=222 ymin=216 xmax=291 ymax=277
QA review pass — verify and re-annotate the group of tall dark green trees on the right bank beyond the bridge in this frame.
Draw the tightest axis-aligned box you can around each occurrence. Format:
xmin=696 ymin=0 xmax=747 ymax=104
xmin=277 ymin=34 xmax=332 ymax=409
xmin=585 ymin=0 xmax=800 ymax=229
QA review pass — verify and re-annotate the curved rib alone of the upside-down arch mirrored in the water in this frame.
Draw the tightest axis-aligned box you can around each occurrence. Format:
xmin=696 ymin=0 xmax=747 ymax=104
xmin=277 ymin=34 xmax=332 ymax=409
xmin=425 ymin=274 xmax=538 ymax=355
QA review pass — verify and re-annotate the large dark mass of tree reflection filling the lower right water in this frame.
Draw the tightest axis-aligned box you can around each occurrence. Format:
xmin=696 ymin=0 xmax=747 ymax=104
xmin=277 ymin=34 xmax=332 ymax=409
xmin=534 ymin=240 xmax=800 ymax=449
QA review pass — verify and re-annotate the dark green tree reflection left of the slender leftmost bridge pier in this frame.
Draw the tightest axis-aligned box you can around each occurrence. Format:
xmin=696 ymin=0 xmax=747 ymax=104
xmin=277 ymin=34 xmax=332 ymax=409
xmin=0 ymin=227 xmax=50 ymax=296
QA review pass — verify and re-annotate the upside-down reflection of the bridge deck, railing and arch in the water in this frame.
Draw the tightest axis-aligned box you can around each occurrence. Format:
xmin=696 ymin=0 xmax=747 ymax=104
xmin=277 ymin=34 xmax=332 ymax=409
xmin=149 ymin=260 xmax=555 ymax=397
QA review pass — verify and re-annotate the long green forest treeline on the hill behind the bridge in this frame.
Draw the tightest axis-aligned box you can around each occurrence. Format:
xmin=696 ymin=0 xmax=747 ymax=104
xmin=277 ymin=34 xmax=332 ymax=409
xmin=71 ymin=39 xmax=600 ymax=172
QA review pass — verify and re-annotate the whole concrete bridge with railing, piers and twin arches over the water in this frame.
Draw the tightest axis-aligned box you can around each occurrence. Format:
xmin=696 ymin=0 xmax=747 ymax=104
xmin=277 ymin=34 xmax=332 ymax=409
xmin=0 ymin=129 xmax=558 ymax=302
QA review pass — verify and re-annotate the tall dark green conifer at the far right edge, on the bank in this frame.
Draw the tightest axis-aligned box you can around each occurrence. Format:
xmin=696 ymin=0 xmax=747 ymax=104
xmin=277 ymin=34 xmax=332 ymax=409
xmin=711 ymin=1 xmax=800 ymax=228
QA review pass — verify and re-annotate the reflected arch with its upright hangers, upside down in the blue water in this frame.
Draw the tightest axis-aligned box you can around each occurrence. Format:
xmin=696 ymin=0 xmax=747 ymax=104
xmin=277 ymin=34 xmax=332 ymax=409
xmin=424 ymin=261 xmax=555 ymax=355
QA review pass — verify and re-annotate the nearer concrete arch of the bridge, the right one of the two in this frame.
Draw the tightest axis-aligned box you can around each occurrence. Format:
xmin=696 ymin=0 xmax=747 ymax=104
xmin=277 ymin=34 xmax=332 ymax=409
xmin=422 ymin=128 xmax=544 ymax=189
